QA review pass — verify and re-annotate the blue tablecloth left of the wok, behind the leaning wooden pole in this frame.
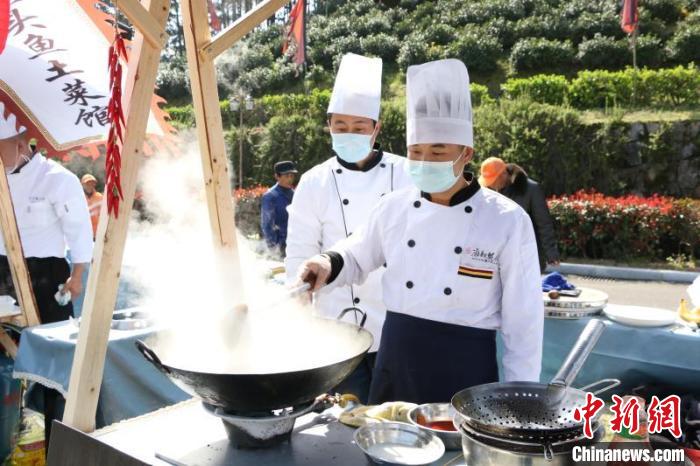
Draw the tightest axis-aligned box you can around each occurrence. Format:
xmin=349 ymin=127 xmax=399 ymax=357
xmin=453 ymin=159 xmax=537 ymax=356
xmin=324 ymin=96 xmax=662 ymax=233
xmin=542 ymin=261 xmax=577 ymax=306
xmin=13 ymin=314 xmax=189 ymax=427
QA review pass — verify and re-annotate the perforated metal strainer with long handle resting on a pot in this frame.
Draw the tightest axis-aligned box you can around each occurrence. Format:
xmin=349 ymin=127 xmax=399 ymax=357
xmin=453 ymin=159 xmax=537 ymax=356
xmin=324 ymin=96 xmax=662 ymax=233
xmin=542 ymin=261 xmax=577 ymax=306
xmin=452 ymin=319 xmax=620 ymax=443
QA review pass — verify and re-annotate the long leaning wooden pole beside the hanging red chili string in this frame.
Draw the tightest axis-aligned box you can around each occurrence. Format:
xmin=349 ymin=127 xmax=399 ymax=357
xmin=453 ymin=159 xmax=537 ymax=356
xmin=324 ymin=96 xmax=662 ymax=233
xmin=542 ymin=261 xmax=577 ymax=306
xmin=63 ymin=0 xmax=170 ymax=432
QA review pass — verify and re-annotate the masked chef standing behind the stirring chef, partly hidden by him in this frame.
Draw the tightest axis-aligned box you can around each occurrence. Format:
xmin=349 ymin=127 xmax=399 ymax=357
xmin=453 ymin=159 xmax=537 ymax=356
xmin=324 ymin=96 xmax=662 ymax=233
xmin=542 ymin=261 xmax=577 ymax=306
xmin=285 ymin=54 xmax=411 ymax=401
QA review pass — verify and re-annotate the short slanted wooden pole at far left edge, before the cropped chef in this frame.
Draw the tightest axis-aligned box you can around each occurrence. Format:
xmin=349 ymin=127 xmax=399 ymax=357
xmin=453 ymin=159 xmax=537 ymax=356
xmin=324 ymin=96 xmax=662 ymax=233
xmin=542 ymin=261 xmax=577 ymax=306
xmin=0 ymin=160 xmax=41 ymax=326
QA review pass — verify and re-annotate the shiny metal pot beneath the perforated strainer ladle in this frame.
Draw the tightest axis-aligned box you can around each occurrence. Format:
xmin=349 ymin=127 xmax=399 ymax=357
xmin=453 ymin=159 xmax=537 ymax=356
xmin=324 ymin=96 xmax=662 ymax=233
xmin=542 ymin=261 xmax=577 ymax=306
xmin=459 ymin=422 xmax=604 ymax=466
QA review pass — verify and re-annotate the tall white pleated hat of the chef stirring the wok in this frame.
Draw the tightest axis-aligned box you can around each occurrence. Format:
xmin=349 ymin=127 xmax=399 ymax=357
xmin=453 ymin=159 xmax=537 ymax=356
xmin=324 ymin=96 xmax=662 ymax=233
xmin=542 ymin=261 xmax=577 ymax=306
xmin=406 ymin=59 xmax=474 ymax=147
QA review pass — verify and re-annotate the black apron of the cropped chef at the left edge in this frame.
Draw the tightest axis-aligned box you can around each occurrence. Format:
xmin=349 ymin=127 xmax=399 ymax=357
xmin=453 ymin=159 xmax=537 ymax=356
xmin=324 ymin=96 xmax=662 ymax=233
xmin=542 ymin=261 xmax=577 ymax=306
xmin=0 ymin=256 xmax=73 ymax=324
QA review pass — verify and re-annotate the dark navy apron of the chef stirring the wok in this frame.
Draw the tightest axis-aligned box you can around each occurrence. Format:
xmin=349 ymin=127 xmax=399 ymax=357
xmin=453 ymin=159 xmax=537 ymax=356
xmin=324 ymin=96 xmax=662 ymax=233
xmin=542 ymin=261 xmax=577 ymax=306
xmin=369 ymin=311 xmax=498 ymax=404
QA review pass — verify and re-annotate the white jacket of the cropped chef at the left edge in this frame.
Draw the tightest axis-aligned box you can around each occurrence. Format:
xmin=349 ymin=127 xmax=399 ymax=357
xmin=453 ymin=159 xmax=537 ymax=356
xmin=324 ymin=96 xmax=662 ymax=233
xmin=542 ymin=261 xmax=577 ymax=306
xmin=0 ymin=153 xmax=93 ymax=264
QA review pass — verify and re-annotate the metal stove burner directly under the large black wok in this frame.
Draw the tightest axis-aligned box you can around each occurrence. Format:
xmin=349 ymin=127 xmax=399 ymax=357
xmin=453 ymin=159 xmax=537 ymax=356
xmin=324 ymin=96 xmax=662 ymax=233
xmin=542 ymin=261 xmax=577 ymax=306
xmin=202 ymin=401 xmax=323 ymax=449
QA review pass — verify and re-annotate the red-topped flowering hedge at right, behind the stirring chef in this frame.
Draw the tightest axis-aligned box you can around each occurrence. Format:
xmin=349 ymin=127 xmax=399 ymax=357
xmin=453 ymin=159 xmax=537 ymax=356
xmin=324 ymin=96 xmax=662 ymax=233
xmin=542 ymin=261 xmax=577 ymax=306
xmin=549 ymin=191 xmax=700 ymax=260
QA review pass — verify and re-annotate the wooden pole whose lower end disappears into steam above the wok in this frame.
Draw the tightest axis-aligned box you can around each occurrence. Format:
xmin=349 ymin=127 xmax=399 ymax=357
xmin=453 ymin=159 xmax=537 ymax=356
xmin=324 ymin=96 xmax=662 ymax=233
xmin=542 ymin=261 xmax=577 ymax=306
xmin=182 ymin=0 xmax=245 ymax=294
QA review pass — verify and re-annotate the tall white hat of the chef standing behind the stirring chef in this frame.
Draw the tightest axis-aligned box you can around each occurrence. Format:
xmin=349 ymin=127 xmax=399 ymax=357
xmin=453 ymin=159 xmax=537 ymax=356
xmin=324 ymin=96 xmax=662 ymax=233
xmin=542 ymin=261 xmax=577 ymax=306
xmin=328 ymin=53 xmax=382 ymax=121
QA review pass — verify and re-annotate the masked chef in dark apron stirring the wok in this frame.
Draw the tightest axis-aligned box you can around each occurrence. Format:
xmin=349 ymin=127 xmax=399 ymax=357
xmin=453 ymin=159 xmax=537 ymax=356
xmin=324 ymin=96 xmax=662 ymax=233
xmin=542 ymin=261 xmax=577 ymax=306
xmin=300 ymin=60 xmax=544 ymax=403
